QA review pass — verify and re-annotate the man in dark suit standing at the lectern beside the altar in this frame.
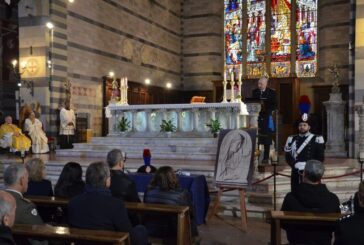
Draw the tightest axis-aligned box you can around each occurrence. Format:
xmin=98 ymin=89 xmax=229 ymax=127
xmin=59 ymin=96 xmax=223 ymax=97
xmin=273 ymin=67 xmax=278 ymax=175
xmin=252 ymin=76 xmax=277 ymax=164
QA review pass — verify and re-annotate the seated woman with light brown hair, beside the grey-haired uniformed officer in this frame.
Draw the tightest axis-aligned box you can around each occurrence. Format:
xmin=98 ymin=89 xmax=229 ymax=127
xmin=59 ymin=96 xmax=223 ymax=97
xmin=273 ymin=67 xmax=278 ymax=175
xmin=24 ymin=158 xmax=54 ymax=222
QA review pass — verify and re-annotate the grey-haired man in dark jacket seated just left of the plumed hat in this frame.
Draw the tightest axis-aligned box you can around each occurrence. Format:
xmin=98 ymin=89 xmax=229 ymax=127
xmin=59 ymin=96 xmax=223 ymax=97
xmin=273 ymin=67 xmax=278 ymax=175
xmin=106 ymin=149 xmax=140 ymax=202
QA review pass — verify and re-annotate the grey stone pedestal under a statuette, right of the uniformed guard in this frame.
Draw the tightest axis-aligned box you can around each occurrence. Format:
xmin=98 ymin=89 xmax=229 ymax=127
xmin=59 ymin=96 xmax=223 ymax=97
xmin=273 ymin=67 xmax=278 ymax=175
xmin=323 ymin=93 xmax=346 ymax=157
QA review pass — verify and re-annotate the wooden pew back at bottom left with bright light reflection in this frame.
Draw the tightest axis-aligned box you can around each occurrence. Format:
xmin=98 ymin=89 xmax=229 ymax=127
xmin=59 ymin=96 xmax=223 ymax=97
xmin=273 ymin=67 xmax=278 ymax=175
xmin=12 ymin=224 xmax=131 ymax=245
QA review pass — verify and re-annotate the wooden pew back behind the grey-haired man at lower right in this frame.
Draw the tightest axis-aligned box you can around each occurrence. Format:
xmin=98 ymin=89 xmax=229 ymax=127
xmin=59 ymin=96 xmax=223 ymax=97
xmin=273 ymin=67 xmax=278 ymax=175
xmin=271 ymin=211 xmax=342 ymax=245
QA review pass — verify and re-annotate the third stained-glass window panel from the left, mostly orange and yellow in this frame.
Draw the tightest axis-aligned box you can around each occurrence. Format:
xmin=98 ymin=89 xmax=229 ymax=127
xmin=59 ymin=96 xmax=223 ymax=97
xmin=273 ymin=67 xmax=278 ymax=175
xmin=271 ymin=0 xmax=291 ymax=77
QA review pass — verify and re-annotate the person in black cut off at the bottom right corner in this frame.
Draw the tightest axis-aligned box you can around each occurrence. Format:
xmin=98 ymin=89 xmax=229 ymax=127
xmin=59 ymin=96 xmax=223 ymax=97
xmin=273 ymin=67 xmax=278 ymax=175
xmin=335 ymin=181 xmax=364 ymax=245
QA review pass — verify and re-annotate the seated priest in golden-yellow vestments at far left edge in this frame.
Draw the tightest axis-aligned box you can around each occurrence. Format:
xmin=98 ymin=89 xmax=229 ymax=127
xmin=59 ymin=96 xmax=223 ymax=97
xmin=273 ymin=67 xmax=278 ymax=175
xmin=0 ymin=116 xmax=31 ymax=152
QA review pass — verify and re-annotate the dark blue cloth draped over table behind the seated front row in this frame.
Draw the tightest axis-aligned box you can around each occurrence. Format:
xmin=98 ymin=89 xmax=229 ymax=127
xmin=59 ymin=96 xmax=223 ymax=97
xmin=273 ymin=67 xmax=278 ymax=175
xmin=128 ymin=174 xmax=210 ymax=225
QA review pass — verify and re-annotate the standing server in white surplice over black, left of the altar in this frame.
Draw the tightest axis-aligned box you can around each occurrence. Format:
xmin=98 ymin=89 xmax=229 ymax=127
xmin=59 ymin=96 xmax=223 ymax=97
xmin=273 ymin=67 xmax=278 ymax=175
xmin=59 ymin=101 xmax=76 ymax=149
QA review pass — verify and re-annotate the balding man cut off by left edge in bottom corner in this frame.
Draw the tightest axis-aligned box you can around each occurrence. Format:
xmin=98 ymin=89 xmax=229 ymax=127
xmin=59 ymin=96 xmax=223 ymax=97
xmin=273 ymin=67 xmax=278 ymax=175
xmin=0 ymin=191 xmax=16 ymax=245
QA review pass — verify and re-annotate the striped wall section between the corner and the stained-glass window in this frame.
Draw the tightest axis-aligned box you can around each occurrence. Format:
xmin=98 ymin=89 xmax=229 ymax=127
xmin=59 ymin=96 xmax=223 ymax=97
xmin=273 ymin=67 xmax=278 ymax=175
xmin=181 ymin=0 xmax=224 ymax=90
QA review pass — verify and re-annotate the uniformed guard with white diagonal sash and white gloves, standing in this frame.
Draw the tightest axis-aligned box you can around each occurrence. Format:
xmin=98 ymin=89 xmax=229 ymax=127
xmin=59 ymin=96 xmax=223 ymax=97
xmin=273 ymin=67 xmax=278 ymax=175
xmin=284 ymin=113 xmax=325 ymax=191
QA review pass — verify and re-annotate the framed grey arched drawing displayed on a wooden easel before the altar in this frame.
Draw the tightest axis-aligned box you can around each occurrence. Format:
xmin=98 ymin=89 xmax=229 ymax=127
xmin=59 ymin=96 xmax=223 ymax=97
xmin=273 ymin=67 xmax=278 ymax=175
xmin=215 ymin=129 xmax=257 ymax=187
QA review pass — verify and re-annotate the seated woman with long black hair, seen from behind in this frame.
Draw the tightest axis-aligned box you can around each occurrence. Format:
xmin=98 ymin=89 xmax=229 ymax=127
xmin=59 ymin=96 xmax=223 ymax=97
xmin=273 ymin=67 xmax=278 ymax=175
xmin=54 ymin=162 xmax=85 ymax=198
